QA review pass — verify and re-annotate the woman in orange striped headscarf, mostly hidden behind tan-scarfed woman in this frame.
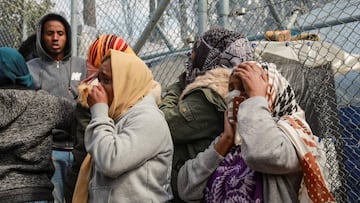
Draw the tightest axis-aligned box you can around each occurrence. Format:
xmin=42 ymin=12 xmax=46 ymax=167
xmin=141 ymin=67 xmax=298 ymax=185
xmin=64 ymin=34 xmax=161 ymax=203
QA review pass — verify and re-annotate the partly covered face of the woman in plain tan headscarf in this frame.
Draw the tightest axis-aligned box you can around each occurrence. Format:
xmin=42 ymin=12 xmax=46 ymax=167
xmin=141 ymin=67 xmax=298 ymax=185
xmin=98 ymin=58 xmax=114 ymax=106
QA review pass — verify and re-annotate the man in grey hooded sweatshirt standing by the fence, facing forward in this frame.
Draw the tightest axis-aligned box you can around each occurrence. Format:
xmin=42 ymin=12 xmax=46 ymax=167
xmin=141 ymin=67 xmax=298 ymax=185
xmin=27 ymin=13 xmax=86 ymax=202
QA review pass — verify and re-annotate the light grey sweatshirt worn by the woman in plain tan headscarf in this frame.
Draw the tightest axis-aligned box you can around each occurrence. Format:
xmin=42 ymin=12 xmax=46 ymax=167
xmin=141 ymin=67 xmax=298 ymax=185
xmin=84 ymin=94 xmax=173 ymax=203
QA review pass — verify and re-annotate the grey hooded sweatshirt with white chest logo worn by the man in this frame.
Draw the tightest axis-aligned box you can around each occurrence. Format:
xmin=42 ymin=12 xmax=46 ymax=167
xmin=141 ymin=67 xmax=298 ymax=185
xmin=27 ymin=13 xmax=86 ymax=150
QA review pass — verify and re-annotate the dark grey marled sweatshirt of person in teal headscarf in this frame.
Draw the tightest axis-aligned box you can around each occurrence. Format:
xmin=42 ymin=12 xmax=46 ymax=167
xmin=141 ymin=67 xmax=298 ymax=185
xmin=0 ymin=89 xmax=74 ymax=203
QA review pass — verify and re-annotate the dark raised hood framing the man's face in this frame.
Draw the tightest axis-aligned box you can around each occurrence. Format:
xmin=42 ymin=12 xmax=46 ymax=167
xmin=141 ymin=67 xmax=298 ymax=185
xmin=36 ymin=13 xmax=71 ymax=60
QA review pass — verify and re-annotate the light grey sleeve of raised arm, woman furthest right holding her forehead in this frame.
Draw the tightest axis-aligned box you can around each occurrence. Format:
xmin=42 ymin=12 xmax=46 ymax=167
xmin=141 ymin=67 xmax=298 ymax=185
xmin=237 ymin=96 xmax=301 ymax=174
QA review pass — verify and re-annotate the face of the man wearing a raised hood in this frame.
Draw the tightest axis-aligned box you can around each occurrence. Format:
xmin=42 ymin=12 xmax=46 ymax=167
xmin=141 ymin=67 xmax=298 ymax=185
xmin=42 ymin=20 xmax=67 ymax=60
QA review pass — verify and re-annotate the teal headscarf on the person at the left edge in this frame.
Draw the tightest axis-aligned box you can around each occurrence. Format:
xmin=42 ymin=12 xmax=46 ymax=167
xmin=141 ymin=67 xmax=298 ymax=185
xmin=0 ymin=47 xmax=33 ymax=87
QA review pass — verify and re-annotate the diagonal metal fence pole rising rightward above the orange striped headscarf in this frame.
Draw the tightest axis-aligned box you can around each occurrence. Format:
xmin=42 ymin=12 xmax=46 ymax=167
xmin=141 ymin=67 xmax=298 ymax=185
xmin=133 ymin=0 xmax=170 ymax=53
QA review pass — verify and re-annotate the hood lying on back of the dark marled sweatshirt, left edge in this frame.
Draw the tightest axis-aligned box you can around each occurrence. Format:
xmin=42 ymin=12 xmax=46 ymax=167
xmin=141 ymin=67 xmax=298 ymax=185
xmin=0 ymin=89 xmax=35 ymax=128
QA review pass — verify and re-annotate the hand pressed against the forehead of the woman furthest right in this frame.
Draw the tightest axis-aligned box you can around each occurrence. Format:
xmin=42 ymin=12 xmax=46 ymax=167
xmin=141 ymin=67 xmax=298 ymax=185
xmin=233 ymin=61 xmax=268 ymax=97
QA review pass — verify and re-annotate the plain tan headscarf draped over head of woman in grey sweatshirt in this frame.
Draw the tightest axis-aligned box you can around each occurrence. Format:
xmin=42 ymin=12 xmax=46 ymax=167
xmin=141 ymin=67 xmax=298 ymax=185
xmin=109 ymin=50 xmax=153 ymax=120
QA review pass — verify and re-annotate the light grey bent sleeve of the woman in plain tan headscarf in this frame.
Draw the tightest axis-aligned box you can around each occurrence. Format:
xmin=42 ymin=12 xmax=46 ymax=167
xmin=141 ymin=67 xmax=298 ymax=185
xmin=84 ymin=103 xmax=170 ymax=178
